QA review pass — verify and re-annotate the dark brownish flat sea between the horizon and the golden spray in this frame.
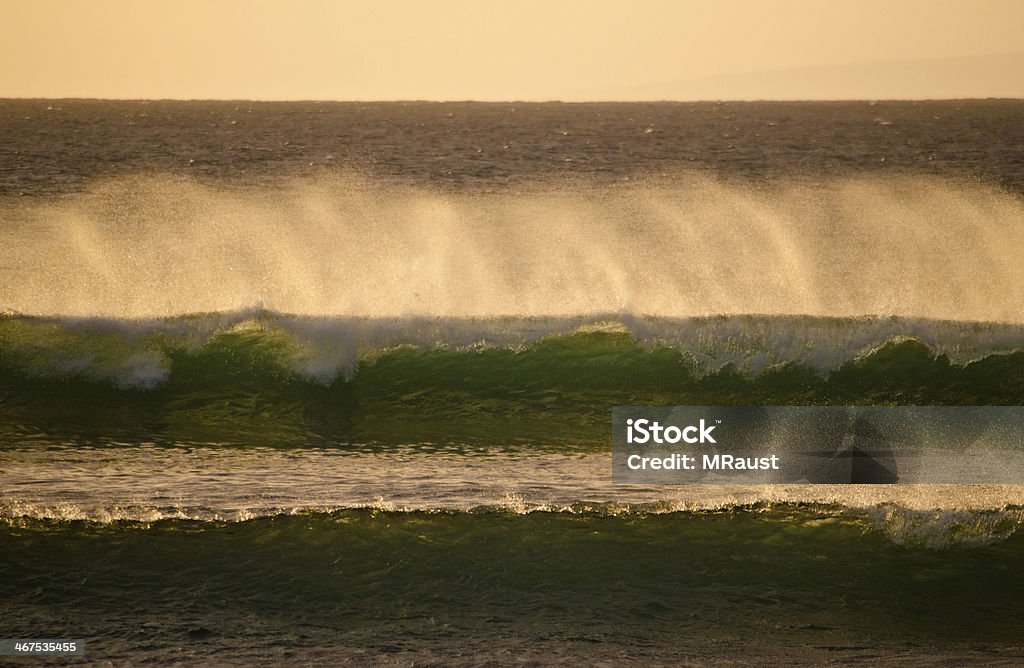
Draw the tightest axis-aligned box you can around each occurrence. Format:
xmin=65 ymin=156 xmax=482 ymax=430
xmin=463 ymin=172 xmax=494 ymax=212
xmin=6 ymin=99 xmax=1024 ymax=195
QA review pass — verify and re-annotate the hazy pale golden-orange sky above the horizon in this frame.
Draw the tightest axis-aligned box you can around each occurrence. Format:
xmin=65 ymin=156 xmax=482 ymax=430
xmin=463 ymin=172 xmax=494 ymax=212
xmin=0 ymin=0 xmax=1024 ymax=100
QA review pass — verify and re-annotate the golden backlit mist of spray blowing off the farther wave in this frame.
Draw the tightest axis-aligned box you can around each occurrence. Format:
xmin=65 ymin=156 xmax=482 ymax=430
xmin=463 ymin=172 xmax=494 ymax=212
xmin=6 ymin=174 xmax=1024 ymax=323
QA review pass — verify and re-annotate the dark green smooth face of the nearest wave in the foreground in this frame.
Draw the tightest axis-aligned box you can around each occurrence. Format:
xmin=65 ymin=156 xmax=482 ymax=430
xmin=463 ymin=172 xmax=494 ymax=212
xmin=6 ymin=506 xmax=1024 ymax=661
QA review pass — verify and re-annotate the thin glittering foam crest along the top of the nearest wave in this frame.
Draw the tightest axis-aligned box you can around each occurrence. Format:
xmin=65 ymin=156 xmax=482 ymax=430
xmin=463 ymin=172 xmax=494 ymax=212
xmin=6 ymin=499 xmax=1024 ymax=549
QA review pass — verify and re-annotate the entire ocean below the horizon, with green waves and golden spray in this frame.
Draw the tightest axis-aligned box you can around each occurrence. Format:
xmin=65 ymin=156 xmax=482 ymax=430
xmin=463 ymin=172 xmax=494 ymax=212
xmin=0 ymin=99 xmax=1024 ymax=666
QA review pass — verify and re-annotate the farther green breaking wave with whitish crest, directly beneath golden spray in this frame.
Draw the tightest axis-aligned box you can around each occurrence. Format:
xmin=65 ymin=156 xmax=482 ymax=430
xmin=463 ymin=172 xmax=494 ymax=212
xmin=0 ymin=311 xmax=1024 ymax=447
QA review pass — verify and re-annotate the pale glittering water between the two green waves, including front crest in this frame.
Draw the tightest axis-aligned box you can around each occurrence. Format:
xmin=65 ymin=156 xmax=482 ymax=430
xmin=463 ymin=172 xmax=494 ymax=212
xmin=8 ymin=443 xmax=1024 ymax=545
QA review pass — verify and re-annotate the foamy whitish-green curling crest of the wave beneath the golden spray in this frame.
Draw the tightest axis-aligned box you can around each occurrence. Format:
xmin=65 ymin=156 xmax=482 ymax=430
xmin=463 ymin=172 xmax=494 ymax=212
xmin=0 ymin=309 xmax=1024 ymax=389
